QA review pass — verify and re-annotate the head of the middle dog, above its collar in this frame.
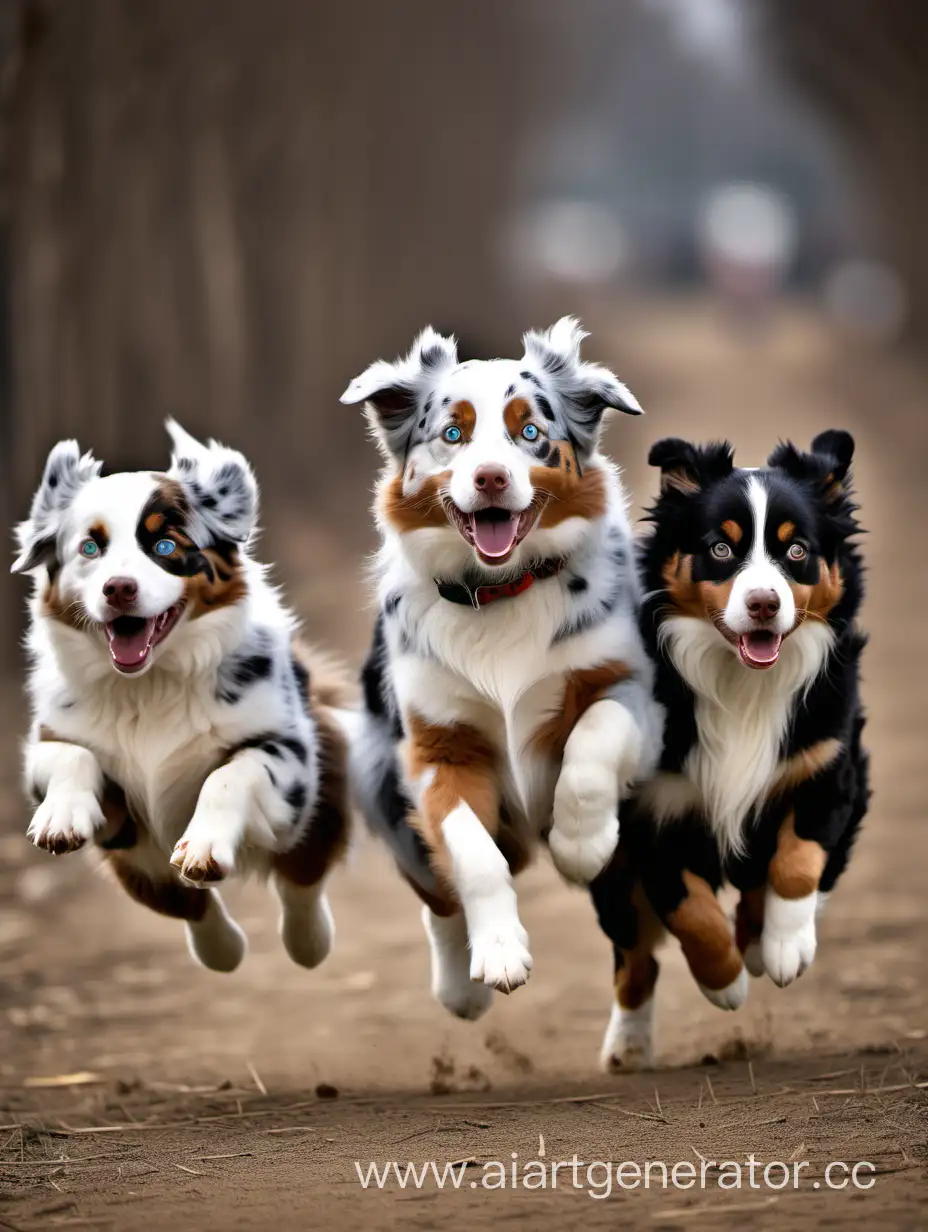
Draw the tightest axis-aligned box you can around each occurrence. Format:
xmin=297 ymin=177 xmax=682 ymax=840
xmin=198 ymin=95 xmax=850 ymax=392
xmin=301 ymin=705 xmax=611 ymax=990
xmin=341 ymin=317 xmax=641 ymax=568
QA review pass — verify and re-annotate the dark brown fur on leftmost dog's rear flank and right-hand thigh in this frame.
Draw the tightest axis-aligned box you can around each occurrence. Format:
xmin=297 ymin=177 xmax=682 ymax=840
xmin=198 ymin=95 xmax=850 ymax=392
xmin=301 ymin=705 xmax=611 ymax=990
xmin=271 ymin=707 xmax=350 ymax=886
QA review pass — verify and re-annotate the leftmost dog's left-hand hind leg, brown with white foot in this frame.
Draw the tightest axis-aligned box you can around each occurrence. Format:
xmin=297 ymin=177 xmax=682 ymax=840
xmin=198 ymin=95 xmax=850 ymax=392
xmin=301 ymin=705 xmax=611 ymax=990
xmin=106 ymin=839 xmax=248 ymax=972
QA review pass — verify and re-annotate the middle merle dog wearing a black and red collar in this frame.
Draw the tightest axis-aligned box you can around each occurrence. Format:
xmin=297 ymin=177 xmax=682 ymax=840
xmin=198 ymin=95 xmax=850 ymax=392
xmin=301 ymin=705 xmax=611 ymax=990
xmin=341 ymin=318 xmax=661 ymax=1018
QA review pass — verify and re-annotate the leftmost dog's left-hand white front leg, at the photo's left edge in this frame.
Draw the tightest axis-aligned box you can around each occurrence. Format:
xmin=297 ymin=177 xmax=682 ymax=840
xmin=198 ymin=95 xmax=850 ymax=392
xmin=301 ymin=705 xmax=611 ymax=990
xmin=26 ymin=728 xmax=106 ymax=855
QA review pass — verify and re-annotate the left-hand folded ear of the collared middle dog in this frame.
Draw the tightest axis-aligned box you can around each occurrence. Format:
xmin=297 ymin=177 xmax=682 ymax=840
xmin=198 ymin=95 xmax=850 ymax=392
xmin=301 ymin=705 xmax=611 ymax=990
xmin=340 ymin=325 xmax=457 ymax=458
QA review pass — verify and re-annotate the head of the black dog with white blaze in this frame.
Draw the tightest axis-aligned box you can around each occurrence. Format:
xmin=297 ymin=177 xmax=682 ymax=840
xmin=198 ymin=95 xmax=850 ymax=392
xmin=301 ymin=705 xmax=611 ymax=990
xmin=646 ymin=431 xmax=858 ymax=669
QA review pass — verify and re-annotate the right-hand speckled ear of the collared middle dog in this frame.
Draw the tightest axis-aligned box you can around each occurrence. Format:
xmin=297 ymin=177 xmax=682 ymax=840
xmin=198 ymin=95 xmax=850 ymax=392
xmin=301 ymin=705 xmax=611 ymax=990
xmin=523 ymin=317 xmax=643 ymax=453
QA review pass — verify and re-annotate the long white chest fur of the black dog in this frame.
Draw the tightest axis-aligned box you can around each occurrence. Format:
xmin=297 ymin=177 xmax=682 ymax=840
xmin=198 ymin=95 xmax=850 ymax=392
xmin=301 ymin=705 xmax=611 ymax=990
xmin=647 ymin=616 xmax=834 ymax=853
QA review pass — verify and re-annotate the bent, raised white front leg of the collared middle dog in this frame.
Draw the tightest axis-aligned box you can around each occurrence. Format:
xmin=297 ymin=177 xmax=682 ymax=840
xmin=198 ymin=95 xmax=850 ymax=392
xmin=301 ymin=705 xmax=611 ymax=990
xmin=548 ymin=697 xmax=642 ymax=885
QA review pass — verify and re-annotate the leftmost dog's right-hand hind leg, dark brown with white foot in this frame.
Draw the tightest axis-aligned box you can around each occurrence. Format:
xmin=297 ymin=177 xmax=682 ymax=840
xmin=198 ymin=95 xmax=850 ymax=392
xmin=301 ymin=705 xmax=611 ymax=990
xmin=271 ymin=707 xmax=350 ymax=968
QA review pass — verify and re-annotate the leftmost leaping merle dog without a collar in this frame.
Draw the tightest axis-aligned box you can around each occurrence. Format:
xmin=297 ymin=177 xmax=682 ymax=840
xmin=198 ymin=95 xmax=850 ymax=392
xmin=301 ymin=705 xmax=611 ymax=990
xmin=12 ymin=423 xmax=348 ymax=971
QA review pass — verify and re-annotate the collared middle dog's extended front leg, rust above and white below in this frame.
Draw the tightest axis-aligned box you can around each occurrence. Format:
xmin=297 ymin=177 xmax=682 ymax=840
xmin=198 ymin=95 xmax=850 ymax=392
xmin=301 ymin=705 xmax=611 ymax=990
xmin=405 ymin=715 xmax=531 ymax=995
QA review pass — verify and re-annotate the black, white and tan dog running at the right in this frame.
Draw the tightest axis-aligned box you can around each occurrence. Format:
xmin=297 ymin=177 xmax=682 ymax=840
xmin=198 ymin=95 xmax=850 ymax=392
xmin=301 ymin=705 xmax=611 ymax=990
xmin=592 ymin=431 xmax=869 ymax=1068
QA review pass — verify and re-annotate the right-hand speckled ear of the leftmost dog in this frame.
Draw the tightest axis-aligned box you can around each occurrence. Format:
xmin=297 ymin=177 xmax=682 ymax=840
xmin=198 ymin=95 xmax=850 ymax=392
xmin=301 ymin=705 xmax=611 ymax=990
xmin=166 ymin=419 xmax=258 ymax=547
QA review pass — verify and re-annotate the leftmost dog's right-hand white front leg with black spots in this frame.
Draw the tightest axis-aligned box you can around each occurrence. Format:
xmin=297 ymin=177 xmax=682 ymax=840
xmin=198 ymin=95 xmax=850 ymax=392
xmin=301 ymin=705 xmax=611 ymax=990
xmin=171 ymin=738 xmax=314 ymax=886
